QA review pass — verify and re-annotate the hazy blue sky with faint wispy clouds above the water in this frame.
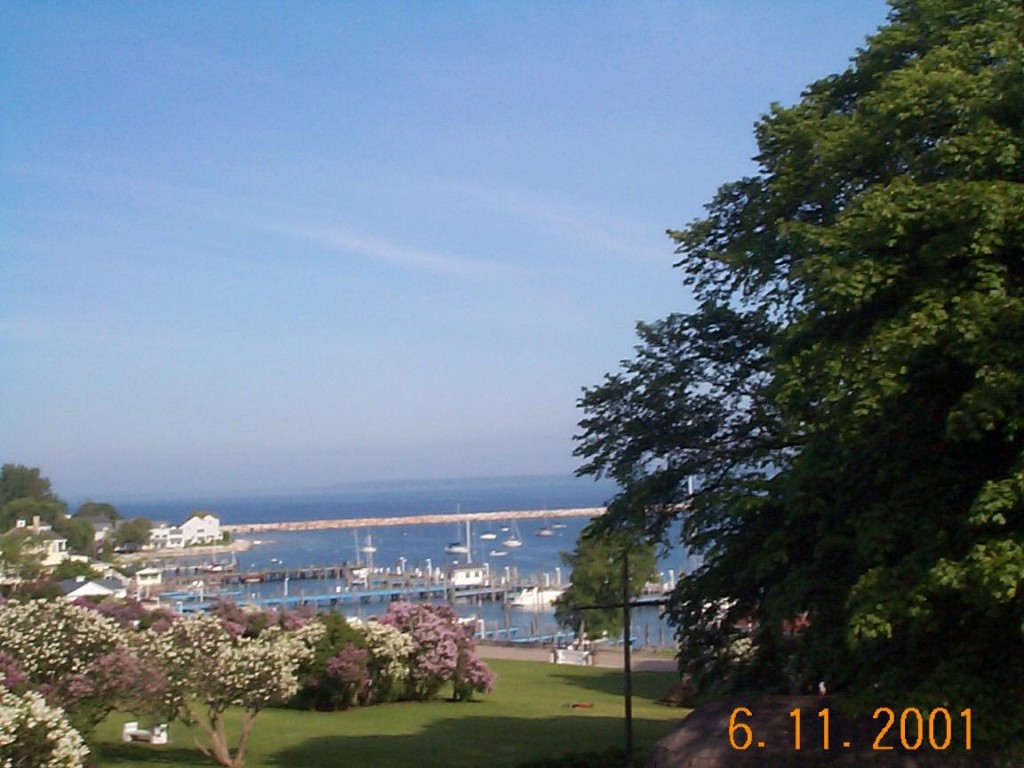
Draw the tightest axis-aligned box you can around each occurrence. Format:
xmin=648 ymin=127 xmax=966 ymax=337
xmin=0 ymin=0 xmax=887 ymax=498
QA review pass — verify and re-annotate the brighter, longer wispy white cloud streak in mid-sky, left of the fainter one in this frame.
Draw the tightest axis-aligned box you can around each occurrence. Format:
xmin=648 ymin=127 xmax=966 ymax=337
xmin=269 ymin=225 xmax=511 ymax=278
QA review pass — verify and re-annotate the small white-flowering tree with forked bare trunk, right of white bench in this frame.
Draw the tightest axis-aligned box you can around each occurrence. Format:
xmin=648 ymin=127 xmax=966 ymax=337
xmin=150 ymin=615 xmax=324 ymax=768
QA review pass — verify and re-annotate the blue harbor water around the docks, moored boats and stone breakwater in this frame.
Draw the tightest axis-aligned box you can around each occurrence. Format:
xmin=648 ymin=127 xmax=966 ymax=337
xmin=115 ymin=477 xmax=692 ymax=647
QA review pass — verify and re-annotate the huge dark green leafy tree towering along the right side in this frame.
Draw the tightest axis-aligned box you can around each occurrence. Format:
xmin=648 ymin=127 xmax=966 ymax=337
xmin=578 ymin=0 xmax=1024 ymax=741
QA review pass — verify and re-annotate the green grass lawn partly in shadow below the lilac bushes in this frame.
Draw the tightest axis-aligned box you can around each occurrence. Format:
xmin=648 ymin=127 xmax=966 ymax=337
xmin=92 ymin=659 xmax=685 ymax=768
